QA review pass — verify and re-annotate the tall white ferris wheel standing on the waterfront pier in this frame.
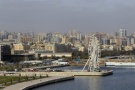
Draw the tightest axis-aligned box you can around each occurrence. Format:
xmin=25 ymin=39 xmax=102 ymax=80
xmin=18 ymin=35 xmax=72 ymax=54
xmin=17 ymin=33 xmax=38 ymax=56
xmin=82 ymin=34 xmax=101 ymax=72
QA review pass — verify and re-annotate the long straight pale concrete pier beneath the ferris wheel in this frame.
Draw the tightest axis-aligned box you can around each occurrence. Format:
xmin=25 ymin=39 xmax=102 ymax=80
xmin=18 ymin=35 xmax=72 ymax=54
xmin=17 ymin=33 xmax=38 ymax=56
xmin=18 ymin=70 xmax=113 ymax=76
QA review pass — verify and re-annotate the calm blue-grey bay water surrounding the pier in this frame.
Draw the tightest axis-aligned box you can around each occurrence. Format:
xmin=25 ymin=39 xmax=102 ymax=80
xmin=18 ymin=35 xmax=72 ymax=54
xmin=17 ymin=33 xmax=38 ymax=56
xmin=33 ymin=67 xmax=135 ymax=90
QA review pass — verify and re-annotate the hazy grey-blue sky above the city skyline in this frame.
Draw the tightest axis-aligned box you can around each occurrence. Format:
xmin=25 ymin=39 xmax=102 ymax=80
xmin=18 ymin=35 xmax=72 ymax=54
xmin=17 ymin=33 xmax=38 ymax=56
xmin=0 ymin=0 xmax=135 ymax=33
